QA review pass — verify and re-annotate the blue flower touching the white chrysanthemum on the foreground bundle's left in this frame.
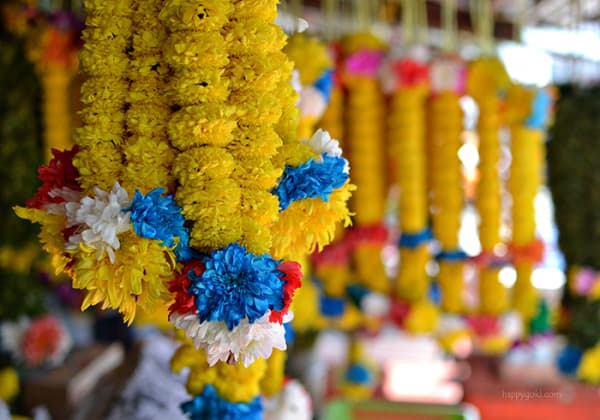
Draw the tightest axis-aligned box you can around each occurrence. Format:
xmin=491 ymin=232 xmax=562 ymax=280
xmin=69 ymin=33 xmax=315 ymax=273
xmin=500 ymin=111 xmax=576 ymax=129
xmin=128 ymin=188 xmax=192 ymax=261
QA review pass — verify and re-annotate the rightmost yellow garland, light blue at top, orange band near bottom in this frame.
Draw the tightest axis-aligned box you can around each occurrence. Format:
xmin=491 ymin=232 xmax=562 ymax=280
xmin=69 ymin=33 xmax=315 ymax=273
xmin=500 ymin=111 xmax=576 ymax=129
xmin=507 ymin=86 xmax=553 ymax=321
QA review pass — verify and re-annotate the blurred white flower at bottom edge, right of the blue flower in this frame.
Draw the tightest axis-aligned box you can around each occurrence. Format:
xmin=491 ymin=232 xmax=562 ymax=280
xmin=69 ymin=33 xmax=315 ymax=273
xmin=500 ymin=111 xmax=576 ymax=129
xmin=263 ymin=379 xmax=313 ymax=420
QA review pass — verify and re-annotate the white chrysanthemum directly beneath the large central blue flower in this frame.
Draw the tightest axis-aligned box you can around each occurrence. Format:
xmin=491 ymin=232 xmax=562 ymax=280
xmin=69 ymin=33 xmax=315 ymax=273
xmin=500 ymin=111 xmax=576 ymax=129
xmin=169 ymin=312 xmax=289 ymax=367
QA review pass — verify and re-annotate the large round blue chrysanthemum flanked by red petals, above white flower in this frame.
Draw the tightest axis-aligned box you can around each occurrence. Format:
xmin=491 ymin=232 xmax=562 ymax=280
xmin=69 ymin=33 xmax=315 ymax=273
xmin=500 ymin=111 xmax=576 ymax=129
xmin=188 ymin=244 xmax=283 ymax=330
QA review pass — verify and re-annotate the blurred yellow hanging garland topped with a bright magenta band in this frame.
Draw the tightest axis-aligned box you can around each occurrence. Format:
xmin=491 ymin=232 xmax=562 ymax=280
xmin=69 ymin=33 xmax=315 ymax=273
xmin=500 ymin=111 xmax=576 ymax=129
xmin=342 ymin=33 xmax=390 ymax=293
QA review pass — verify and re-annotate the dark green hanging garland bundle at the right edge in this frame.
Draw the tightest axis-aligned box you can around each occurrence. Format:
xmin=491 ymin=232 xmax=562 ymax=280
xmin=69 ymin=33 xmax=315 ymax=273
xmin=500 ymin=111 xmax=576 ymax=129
xmin=547 ymin=86 xmax=600 ymax=384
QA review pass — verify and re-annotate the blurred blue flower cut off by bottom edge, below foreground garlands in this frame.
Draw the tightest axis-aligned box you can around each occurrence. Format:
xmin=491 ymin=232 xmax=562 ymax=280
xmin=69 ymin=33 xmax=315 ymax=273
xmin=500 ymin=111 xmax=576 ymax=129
xmin=181 ymin=384 xmax=263 ymax=420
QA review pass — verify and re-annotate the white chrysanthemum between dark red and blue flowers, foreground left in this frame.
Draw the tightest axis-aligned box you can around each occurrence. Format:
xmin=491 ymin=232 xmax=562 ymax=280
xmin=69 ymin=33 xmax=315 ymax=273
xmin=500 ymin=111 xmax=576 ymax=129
xmin=66 ymin=182 xmax=131 ymax=263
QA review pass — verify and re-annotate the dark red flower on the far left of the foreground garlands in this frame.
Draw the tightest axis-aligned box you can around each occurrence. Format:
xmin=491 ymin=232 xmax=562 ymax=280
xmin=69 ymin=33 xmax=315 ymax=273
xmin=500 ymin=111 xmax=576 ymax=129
xmin=25 ymin=146 xmax=81 ymax=209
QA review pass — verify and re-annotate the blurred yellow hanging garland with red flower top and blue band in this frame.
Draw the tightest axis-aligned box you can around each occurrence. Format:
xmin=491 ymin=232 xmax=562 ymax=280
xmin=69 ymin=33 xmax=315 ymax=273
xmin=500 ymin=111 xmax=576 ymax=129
xmin=381 ymin=50 xmax=432 ymax=302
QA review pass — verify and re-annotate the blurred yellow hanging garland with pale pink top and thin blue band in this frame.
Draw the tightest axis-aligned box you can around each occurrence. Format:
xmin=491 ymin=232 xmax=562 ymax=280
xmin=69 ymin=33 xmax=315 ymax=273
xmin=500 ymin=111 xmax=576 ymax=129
xmin=427 ymin=57 xmax=466 ymax=314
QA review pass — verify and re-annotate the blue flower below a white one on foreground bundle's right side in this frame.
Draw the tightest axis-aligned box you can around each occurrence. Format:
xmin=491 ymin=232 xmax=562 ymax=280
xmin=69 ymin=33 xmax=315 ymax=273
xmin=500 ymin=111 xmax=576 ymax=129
xmin=273 ymin=154 xmax=348 ymax=211
